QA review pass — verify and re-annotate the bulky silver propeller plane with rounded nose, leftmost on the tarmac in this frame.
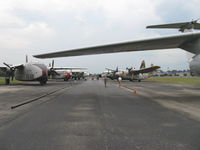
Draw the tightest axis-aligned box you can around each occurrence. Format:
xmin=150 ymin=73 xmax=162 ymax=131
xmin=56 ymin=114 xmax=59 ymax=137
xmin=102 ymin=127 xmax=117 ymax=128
xmin=0 ymin=57 xmax=48 ymax=85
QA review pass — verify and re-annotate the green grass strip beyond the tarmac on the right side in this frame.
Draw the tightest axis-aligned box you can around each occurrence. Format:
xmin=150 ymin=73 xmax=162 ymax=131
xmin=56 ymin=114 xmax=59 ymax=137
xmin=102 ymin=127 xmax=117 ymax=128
xmin=147 ymin=77 xmax=200 ymax=85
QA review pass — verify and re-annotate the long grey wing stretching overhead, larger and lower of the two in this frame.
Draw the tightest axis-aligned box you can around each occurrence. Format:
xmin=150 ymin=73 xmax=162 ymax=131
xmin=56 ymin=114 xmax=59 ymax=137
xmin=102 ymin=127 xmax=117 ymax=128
xmin=34 ymin=32 xmax=200 ymax=58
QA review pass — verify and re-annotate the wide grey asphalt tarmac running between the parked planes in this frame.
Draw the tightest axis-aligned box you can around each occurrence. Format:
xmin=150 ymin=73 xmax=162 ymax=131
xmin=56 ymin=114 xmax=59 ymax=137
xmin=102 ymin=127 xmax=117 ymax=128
xmin=0 ymin=80 xmax=200 ymax=150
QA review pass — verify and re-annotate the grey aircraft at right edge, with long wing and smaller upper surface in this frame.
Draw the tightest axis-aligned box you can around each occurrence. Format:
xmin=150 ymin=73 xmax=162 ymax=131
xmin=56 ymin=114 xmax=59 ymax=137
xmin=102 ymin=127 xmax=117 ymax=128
xmin=34 ymin=20 xmax=200 ymax=76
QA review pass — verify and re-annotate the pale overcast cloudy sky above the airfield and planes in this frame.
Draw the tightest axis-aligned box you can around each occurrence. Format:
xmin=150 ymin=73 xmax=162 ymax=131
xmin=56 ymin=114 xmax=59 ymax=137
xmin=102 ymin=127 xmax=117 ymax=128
xmin=0 ymin=0 xmax=200 ymax=72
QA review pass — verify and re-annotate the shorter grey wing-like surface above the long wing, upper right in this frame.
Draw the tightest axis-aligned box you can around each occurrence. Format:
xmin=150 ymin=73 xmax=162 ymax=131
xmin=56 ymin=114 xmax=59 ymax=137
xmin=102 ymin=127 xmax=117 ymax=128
xmin=146 ymin=20 xmax=200 ymax=32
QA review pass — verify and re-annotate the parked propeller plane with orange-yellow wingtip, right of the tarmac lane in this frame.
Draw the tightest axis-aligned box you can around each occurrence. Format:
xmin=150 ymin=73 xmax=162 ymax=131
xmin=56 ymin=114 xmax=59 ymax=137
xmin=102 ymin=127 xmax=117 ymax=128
xmin=106 ymin=60 xmax=160 ymax=82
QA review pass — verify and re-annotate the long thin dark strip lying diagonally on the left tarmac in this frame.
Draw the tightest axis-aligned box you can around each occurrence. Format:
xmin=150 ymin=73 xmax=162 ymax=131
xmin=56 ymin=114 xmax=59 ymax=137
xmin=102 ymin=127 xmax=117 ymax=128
xmin=10 ymin=86 xmax=70 ymax=109
